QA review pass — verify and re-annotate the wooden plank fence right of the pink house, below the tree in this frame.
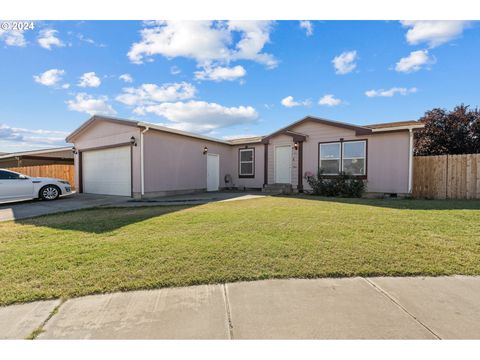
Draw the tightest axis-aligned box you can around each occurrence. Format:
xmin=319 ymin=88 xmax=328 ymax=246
xmin=413 ymin=154 xmax=480 ymax=199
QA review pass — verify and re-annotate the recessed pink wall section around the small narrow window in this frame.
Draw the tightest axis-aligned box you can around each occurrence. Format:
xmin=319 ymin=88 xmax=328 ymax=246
xmin=231 ymin=144 xmax=265 ymax=189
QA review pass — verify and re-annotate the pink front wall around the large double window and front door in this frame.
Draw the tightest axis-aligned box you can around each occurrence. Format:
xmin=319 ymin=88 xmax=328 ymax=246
xmin=268 ymin=122 xmax=409 ymax=194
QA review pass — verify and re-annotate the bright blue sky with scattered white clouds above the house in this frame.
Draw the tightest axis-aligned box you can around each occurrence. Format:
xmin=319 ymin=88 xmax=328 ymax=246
xmin=0 ymin=20 xmax=480 ymax=152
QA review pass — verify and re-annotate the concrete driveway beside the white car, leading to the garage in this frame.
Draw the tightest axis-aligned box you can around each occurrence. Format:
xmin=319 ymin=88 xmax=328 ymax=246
xmin=0 ymin=194 xmax=131 ymax=221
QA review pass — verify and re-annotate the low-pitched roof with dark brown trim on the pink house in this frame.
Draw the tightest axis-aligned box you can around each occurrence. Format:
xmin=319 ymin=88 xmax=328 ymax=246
xmin=66 ymin=115 xmax=423 ymax=146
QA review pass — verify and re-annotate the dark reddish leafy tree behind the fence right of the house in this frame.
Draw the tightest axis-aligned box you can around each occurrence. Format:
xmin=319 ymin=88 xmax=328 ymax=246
xmin=414 ymin=104 xmax=480 ymax=155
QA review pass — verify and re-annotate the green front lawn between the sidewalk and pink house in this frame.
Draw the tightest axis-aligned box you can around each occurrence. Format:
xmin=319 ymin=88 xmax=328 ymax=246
xmin=0 ymin=196 xmax=480 ymax=305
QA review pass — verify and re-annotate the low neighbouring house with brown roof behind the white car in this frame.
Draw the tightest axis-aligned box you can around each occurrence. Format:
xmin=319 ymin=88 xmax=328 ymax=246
xmin=0 ymin=146 xmax=73 ymax=168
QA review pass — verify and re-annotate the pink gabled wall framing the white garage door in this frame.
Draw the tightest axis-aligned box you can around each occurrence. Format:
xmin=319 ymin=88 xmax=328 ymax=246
xmin=74 ymin=121 xmax=141 ymax=194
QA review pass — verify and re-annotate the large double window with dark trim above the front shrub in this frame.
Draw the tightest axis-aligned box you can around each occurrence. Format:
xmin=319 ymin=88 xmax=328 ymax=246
xmin=319 ymin=140 xmax=367 ymax=176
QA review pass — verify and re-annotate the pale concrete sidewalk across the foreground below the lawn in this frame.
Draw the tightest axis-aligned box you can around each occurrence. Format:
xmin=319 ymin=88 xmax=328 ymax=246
xmin=0 ymin=276 xmax=480 ymax=339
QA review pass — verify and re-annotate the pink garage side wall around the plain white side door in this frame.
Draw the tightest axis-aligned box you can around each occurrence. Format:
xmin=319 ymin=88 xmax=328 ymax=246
xmin=144 ymin=130 xmax=233 ymax=195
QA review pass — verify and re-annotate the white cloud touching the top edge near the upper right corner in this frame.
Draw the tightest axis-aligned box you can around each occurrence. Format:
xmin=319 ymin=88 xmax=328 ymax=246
xmin=401 ymin=20 xmax=470 ymax=48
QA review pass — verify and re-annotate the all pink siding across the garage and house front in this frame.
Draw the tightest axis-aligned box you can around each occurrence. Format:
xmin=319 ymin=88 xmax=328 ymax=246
xmin=69 ymin=117 xmax=409 ymax=195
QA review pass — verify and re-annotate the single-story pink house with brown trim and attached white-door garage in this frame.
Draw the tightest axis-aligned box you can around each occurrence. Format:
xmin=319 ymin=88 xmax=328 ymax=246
xmin=66 ymin=116 xmax=423 ymax=197
